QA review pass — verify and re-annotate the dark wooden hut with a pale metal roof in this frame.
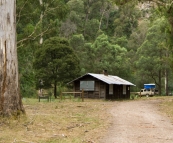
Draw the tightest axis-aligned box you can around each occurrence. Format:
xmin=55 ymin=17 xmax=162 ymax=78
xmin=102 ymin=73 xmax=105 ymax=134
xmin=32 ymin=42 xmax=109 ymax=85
xmin=69 ymin=72 xmax=135 ymax=99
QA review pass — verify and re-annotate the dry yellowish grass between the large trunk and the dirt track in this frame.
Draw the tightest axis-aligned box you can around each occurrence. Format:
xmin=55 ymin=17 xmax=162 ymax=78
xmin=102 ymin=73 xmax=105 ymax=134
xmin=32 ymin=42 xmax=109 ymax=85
xmin=0 ymin=99 xmax=113 ymax=143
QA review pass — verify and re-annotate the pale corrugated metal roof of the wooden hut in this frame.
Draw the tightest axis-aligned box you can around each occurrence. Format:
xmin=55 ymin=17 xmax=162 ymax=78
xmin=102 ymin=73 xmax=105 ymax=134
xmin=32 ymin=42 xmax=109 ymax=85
xmin=69 ymin=73 xmax=135 ymax=86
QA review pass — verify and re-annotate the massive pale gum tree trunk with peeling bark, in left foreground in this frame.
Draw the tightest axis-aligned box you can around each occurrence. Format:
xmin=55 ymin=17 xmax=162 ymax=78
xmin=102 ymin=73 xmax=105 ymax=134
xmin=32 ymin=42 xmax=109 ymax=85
xmin=0 ymin=0 xmax=25 ymax=116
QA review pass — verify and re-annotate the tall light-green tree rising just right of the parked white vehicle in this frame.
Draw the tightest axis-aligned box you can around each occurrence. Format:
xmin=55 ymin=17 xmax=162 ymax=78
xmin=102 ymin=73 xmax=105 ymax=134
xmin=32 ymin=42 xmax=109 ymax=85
xmin=137 ymin=17 xmax=171 ymax=95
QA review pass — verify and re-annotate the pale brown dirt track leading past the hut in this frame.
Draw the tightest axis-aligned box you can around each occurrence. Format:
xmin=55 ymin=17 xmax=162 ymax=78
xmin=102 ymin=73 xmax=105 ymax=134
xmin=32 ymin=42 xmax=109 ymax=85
xmin=100 ymin=100 xmax=173 ymax=143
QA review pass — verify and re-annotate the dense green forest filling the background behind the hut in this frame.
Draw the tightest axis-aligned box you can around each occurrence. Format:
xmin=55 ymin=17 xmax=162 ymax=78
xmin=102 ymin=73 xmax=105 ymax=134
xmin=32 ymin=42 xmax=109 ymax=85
xmin=17 ymin=0 xmax=173 ymax=96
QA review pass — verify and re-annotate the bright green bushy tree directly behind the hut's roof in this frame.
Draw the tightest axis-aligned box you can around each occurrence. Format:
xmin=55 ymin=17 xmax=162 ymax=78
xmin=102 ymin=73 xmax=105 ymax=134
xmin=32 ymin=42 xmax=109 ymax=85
xmin=88 ymin=34 xmax=129 ymax=78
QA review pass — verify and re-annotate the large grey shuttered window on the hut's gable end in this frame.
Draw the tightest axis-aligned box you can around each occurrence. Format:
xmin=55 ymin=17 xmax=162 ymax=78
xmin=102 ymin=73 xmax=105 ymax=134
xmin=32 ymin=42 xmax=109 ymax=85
xmin=80 ymin=81 xmax=95 ymax=91
